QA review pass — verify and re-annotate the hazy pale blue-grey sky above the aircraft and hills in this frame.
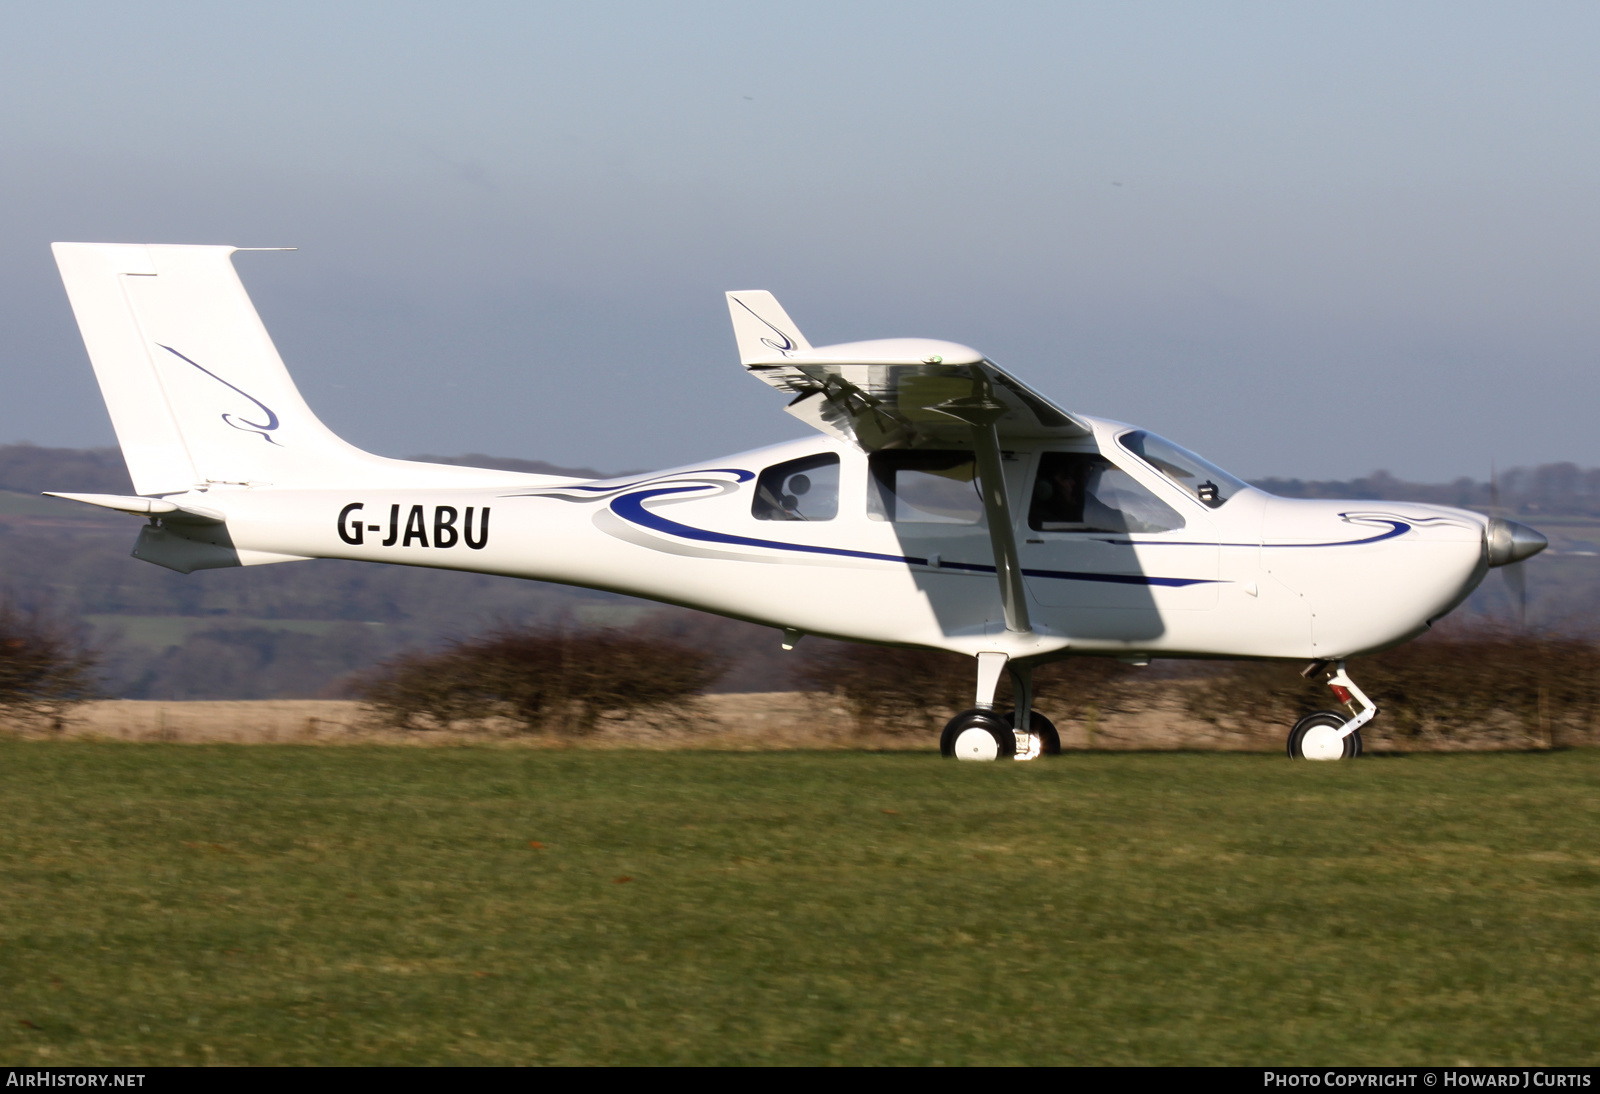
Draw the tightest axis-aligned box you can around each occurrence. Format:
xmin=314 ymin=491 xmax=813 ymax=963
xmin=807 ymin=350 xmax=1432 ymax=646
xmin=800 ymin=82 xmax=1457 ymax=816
xmin=0 ymin=0 xmax=1600 ymax=478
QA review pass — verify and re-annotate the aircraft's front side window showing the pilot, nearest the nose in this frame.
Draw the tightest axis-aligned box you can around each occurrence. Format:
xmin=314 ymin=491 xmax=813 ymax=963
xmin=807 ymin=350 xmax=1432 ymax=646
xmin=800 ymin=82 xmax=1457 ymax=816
xmin=1027 ymin=453 xmax=1184 ymax=533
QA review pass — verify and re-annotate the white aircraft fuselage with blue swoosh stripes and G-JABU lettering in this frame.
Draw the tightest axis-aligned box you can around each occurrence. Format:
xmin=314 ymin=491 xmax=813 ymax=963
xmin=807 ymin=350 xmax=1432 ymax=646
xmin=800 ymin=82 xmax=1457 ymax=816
xmin=150 ymin=419 xmax=1488 ymax=659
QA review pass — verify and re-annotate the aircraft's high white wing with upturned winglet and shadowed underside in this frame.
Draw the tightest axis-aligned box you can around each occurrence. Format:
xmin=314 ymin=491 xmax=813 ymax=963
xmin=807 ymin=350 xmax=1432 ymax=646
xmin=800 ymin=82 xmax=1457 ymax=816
xmin=728 ymin=289 xmax=1091 ymax=453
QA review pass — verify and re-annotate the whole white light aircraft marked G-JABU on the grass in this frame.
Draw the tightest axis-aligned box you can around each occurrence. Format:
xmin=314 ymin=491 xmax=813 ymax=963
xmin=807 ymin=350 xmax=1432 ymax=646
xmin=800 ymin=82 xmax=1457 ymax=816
xmin=54 ymin=243 xmax=1546 ymax=760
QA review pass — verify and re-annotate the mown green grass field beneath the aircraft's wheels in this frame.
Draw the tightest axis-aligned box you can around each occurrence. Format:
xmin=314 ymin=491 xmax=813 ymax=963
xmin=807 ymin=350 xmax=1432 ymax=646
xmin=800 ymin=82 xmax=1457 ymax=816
xmin=0 ymin=741 xmax=1600 ymax=1065
